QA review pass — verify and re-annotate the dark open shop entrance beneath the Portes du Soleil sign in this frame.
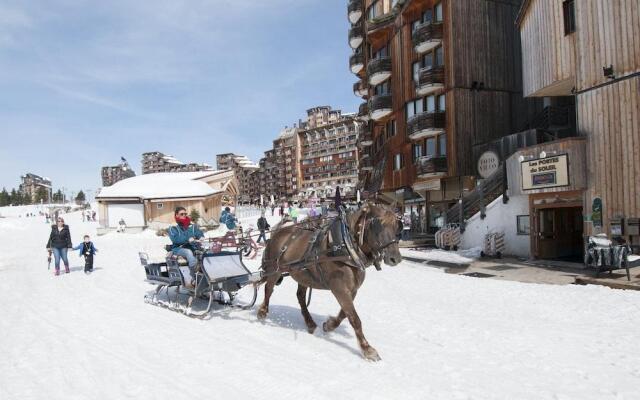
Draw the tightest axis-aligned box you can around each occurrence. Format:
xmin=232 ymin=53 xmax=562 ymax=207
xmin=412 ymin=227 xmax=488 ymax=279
xmin=532 ymin=204 xmax=584 ymax=262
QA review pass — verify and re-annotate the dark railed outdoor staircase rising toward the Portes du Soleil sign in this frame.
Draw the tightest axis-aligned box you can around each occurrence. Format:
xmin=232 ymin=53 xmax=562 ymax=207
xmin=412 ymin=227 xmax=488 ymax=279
xmin=446 ymin=163 xmax=509 ymax=227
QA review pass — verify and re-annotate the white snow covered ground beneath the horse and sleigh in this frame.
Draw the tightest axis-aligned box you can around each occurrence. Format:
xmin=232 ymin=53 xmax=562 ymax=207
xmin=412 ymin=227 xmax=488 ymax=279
xmin=0 ymin=208 xmax=640 ymax=400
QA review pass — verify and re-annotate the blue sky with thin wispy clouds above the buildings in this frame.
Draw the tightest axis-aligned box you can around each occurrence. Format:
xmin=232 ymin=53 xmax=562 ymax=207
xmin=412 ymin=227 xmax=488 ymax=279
xmin=0 ymin=0 xmax=360 ymax=191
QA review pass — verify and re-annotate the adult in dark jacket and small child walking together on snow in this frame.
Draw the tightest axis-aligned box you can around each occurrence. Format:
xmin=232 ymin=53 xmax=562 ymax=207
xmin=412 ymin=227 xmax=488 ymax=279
xmin=47 ymin=216 xmax=98 ymax=276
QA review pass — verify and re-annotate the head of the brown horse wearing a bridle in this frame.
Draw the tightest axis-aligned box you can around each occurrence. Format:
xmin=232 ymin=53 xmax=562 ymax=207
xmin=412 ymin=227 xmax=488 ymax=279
xmin=354 ymin=203 xmax=402 ymax=268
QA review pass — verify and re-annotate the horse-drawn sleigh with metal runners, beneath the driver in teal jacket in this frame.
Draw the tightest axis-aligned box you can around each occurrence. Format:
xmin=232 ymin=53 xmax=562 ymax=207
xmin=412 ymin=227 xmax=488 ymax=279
xmin=139 ymin=250 xmax=261 ymax=317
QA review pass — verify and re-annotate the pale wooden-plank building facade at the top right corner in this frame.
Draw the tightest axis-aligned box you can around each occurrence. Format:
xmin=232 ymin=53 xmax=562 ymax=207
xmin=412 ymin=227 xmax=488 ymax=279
xmin=517 ymin=0 xmax=640 ymax=250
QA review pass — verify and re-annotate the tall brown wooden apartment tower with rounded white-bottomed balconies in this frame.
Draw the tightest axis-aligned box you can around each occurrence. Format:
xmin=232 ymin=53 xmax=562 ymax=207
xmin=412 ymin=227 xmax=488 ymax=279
xmin=347 ymin=0 xmax=539 ymax=231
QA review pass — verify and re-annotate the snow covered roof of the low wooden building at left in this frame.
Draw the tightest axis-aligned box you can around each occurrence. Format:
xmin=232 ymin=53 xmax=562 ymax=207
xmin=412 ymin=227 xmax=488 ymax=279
xmin=96 ymin=171 xmax=221 ymax=200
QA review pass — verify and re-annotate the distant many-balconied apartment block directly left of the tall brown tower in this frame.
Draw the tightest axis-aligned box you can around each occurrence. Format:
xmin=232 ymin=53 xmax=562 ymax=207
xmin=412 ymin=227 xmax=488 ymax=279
xmin=298 ymin=106 xmax=363 ymax=199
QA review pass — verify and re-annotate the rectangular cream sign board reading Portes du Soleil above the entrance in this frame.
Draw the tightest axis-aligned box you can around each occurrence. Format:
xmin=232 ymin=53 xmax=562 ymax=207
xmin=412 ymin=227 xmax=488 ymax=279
xmin=520 ymin=154 xmax=569 ymax=190
